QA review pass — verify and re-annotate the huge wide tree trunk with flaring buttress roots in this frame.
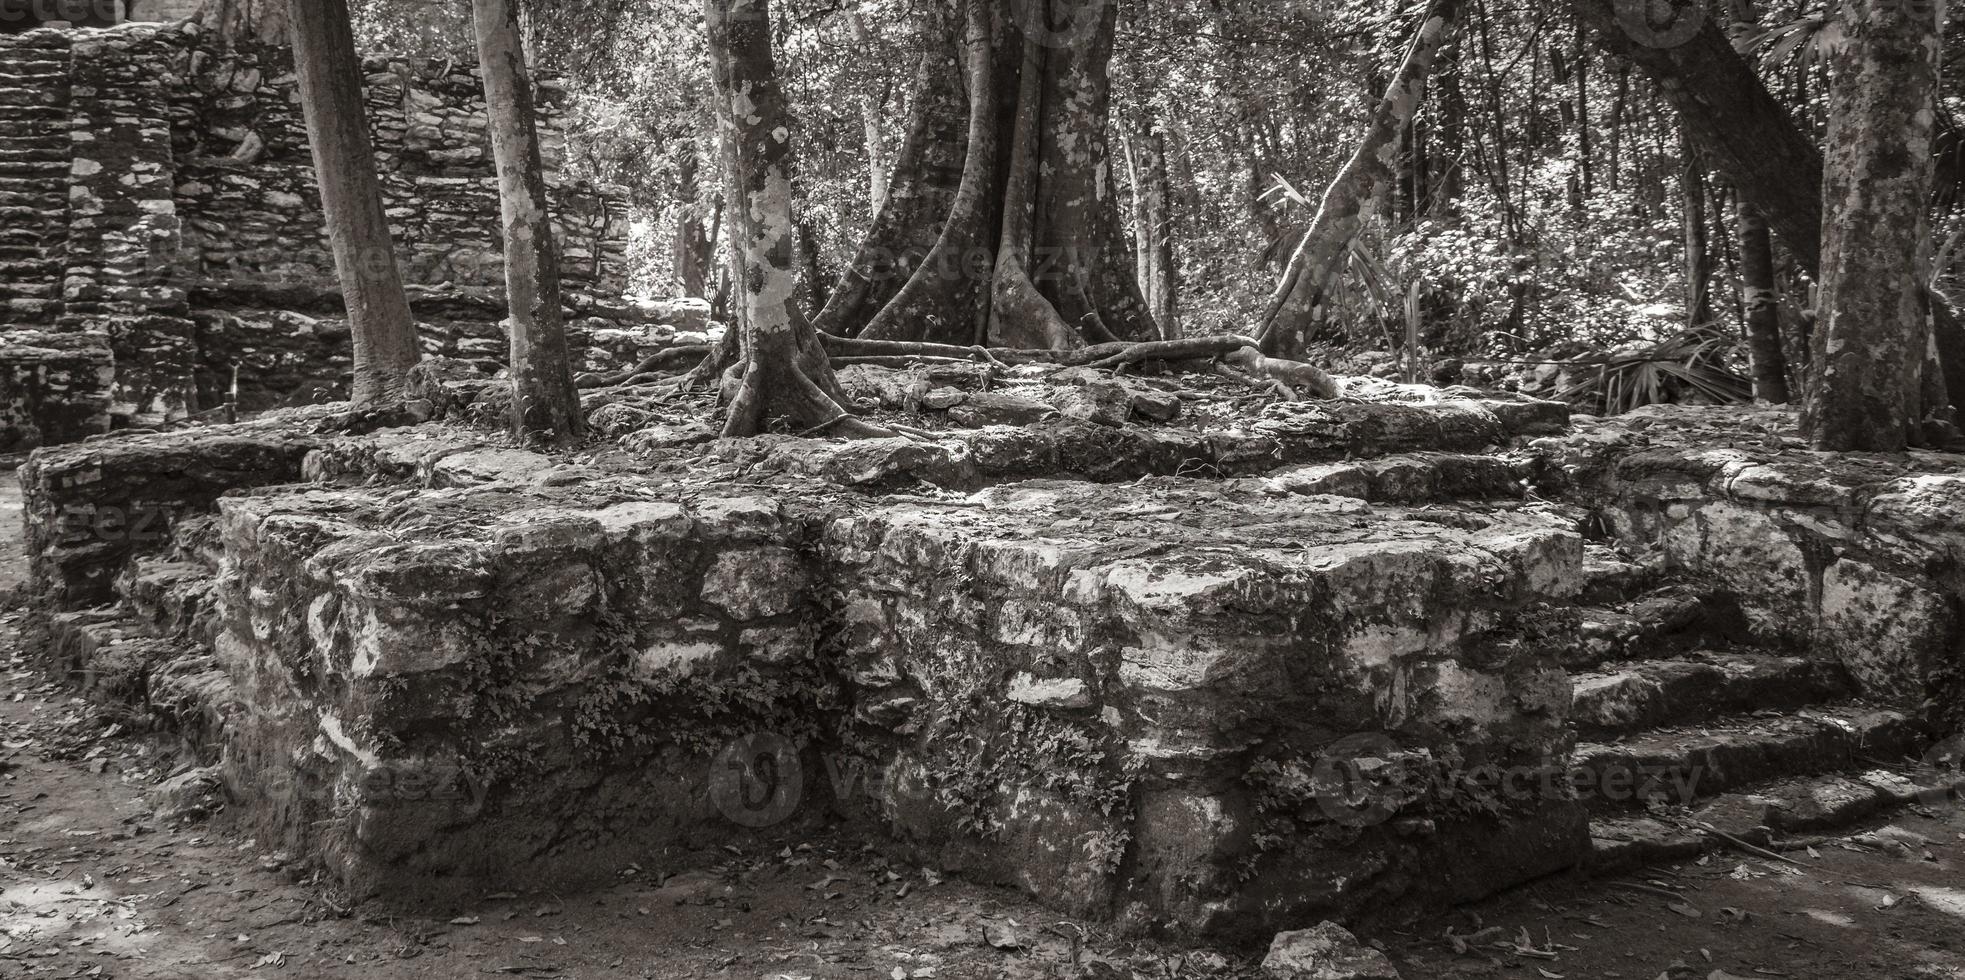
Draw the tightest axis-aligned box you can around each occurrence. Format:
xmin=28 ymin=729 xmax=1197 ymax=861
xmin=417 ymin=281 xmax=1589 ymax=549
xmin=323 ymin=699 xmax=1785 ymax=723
xmin=817 ymin=0 xmax=1155 ymax=348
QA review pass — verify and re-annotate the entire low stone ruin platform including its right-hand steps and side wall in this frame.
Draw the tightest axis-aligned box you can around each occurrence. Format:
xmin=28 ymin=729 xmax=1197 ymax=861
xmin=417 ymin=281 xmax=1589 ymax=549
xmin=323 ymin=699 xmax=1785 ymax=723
xmin=22 ymin=390 xmax=1965 ymax=939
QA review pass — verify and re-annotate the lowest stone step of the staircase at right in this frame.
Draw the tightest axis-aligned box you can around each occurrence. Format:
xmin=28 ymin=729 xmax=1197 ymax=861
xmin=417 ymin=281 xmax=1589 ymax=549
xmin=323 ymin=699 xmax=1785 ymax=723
xmin=1590 ymin=768 xmax=1965 ymax=876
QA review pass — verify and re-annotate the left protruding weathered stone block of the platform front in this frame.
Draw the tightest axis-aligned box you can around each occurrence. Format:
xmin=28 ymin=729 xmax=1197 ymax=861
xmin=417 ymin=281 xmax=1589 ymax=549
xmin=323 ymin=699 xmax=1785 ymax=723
xmin=209 ymin=483 xmax=825 ymax=890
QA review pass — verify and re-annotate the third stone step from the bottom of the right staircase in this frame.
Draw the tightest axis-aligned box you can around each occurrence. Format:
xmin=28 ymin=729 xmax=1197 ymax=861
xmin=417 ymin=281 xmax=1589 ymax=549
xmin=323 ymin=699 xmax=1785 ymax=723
xmin=1570 ymin=652 xmax=1855 ymax=736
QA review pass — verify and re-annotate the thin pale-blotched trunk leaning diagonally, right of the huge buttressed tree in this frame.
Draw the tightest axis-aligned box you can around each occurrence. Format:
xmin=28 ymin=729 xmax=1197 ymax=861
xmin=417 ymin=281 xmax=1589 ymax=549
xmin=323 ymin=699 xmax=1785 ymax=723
xmin=1258 ymin=0 xmax=1456 ymax=355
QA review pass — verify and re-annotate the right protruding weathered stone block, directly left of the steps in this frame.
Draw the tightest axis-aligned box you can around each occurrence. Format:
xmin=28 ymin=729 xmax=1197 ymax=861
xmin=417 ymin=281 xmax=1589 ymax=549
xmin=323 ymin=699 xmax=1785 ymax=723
xmin=825 ymin=481 xmax=1586 ymax=935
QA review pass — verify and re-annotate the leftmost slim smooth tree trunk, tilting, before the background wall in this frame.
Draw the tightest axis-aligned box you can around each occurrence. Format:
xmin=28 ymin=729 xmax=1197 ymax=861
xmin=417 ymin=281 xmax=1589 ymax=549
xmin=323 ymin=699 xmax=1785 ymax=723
xmin=291 ymin=0 xmax=422 ymax=407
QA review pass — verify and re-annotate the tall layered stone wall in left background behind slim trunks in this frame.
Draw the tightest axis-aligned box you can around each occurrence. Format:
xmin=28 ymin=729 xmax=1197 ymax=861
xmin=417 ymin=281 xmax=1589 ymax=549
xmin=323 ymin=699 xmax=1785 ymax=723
xmin=0 ymin=24 xmax=627 ymax=416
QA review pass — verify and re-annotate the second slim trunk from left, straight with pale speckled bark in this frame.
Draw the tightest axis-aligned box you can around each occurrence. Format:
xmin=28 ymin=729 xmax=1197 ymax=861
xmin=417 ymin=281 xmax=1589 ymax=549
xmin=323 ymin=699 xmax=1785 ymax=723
xmin=472 ymin=0 xmax=584 ymax=446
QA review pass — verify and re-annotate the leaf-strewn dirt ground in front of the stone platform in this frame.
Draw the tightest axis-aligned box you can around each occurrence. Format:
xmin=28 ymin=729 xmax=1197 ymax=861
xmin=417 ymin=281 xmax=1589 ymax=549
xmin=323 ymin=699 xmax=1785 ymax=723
xmin=0 ymin=473 xmax=1965 ymax=980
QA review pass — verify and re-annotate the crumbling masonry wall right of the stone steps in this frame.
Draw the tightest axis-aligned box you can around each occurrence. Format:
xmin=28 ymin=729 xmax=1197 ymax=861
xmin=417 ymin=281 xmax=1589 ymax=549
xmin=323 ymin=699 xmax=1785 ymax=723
xmin=1546 ymin=407 xmax=1965 ymax=731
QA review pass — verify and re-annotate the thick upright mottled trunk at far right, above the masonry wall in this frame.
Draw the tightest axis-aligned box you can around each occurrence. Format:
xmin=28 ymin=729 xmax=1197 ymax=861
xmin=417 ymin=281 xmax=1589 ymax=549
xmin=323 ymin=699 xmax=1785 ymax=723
xmin=1802 ymin=0 xmax=1943 ymax=452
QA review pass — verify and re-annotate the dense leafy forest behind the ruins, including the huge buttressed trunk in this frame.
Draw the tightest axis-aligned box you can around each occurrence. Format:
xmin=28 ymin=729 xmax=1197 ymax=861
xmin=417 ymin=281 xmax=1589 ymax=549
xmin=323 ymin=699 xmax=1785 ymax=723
xmin=330 ymin=0 xmax=1965 ymax=449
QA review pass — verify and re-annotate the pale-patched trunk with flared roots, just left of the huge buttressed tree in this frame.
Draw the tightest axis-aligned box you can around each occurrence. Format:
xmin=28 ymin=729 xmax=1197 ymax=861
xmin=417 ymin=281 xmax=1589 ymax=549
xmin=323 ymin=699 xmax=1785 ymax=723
xmin=703 ymin=0 xmax=884 ymax=436
